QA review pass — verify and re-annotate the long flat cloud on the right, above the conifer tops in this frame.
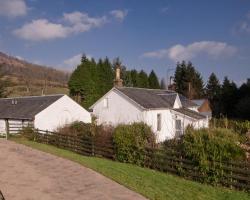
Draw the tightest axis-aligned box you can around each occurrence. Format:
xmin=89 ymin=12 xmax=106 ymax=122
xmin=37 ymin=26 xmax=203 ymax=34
xmin=143 ymin=41 xmax=237 ymax=61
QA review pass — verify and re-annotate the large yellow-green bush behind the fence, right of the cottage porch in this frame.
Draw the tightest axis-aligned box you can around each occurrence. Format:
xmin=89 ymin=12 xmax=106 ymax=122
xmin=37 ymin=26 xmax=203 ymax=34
xmin=183 ymin=128 xmax=244 ymax=163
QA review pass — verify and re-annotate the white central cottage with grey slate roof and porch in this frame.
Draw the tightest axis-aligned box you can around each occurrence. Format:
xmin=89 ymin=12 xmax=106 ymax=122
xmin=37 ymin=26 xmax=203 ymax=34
xmin=90 ymin=87 xmax=208 ymax=142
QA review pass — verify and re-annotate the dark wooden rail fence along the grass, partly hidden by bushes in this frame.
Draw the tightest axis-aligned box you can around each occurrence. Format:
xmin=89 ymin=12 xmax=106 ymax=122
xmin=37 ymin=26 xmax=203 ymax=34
xmin=32 ymin=130 xmax=250 ymax=191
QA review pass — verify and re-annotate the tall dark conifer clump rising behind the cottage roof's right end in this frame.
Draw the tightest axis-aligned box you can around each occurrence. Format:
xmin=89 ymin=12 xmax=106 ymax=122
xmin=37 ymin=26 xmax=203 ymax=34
xmin=174 ymin=61 xmax=204 ymax=99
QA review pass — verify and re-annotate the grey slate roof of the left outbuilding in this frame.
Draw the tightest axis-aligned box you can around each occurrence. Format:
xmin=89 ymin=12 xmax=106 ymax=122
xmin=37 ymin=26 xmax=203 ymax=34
xmin=0 ymin=94 xmax=64 ymax=120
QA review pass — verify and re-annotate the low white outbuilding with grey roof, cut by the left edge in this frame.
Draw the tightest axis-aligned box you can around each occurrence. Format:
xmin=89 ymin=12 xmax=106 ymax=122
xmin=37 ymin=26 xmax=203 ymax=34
xmin=0 ymin=94 xmax=91 ymax=134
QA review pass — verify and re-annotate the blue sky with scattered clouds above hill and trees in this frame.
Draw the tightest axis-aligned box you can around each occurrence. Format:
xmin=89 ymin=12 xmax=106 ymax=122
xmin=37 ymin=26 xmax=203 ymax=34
xmin=0 ymin=0 xmax=250 ymax=85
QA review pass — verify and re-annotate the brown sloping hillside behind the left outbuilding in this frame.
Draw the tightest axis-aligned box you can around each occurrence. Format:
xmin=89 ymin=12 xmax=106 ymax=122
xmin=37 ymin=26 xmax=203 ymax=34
xmin=0 ymin=52 xmax=69 ymax=96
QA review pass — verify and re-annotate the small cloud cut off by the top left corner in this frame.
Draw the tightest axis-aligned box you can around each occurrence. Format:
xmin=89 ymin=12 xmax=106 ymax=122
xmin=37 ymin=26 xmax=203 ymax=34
xmin=0 ymin=0 xmax=28 ymax=17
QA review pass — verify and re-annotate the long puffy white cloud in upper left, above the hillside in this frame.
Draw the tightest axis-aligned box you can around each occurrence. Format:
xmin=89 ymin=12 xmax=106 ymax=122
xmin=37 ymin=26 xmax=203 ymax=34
xmin=13 ymin=12 xmax=107 ymax=41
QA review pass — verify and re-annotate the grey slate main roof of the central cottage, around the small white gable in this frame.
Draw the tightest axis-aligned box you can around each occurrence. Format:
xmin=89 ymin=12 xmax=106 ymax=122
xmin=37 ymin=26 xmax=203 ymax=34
xmin=116 ymin=87 xmax=197 ymax=109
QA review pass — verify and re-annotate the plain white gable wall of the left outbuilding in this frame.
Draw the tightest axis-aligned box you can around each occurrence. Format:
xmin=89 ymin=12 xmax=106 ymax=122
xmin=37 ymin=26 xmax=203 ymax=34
xmin=34 ymin=95 xmax=91 ymax=131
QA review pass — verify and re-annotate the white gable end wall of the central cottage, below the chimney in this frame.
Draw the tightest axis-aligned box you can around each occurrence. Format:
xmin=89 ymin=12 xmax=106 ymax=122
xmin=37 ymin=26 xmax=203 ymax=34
xmin=93 ymin=90 xmax=143 ymax=126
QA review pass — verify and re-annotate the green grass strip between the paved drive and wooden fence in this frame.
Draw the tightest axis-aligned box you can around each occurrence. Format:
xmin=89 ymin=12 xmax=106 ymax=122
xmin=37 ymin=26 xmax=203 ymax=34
xmin=13 ymin=139 xmax=250 ymax=200
